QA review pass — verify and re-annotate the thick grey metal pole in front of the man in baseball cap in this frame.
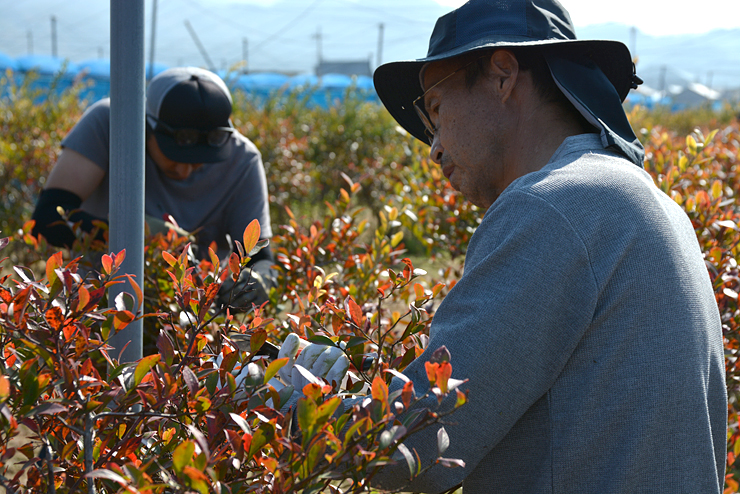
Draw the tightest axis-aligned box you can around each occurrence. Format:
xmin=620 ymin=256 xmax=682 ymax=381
xmin=108 ymin=0 xmax=145 ymax=362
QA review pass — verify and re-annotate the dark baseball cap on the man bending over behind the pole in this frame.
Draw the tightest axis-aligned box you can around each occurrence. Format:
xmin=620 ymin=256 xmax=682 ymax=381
xmin=146 ymin=67 xmax=234 ymax=163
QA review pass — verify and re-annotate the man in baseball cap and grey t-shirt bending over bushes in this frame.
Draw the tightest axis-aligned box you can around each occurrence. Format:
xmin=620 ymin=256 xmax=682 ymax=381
xmin=33 ymin=67 xmax=275 ymax=307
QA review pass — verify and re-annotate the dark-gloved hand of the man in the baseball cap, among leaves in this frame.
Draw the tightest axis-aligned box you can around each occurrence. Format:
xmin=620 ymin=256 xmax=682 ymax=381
xmin=218 ymin=259 xmax=277 ymax=310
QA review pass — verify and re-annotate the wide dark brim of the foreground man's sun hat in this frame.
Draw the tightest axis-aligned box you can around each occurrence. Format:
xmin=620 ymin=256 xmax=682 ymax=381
xmin=373 ymin=39 xmax=632 ymax=144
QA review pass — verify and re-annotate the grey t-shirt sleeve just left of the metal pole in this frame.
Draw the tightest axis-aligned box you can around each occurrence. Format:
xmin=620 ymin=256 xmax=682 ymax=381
xmin=62 ymin=99 xmax=110 ymax=171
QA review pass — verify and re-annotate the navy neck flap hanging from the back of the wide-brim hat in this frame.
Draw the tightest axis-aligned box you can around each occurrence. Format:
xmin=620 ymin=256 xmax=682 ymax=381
xmin=545 ymin=54 xmax=645 ymax=168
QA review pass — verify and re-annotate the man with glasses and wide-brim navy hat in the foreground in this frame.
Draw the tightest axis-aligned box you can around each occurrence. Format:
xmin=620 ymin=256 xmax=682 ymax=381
xmin=362 ymin=0 xmax=727 ymax=494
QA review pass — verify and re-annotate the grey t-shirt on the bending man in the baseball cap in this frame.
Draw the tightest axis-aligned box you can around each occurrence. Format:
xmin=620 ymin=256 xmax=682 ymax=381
xmin=62 ymin=99 xmax=272 ymax=255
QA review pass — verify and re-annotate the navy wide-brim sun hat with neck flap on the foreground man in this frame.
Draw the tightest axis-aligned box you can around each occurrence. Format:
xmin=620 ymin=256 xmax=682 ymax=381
xmin=373 ymin=0 xmax=644 ymax=166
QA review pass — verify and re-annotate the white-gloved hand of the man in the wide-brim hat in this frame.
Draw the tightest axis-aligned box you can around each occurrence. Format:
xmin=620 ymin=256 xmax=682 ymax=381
xmin=278 ymin=333 xmax=349 ymax=391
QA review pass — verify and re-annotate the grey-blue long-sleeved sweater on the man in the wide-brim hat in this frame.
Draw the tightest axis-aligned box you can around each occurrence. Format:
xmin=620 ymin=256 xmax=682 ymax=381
xmin=352 ymin=134 xmax=727 ymax=494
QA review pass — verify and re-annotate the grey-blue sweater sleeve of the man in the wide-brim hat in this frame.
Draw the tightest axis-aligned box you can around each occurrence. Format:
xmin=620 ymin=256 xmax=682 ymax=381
xmin=373 ymin=191 xmax=597 ymax=492
